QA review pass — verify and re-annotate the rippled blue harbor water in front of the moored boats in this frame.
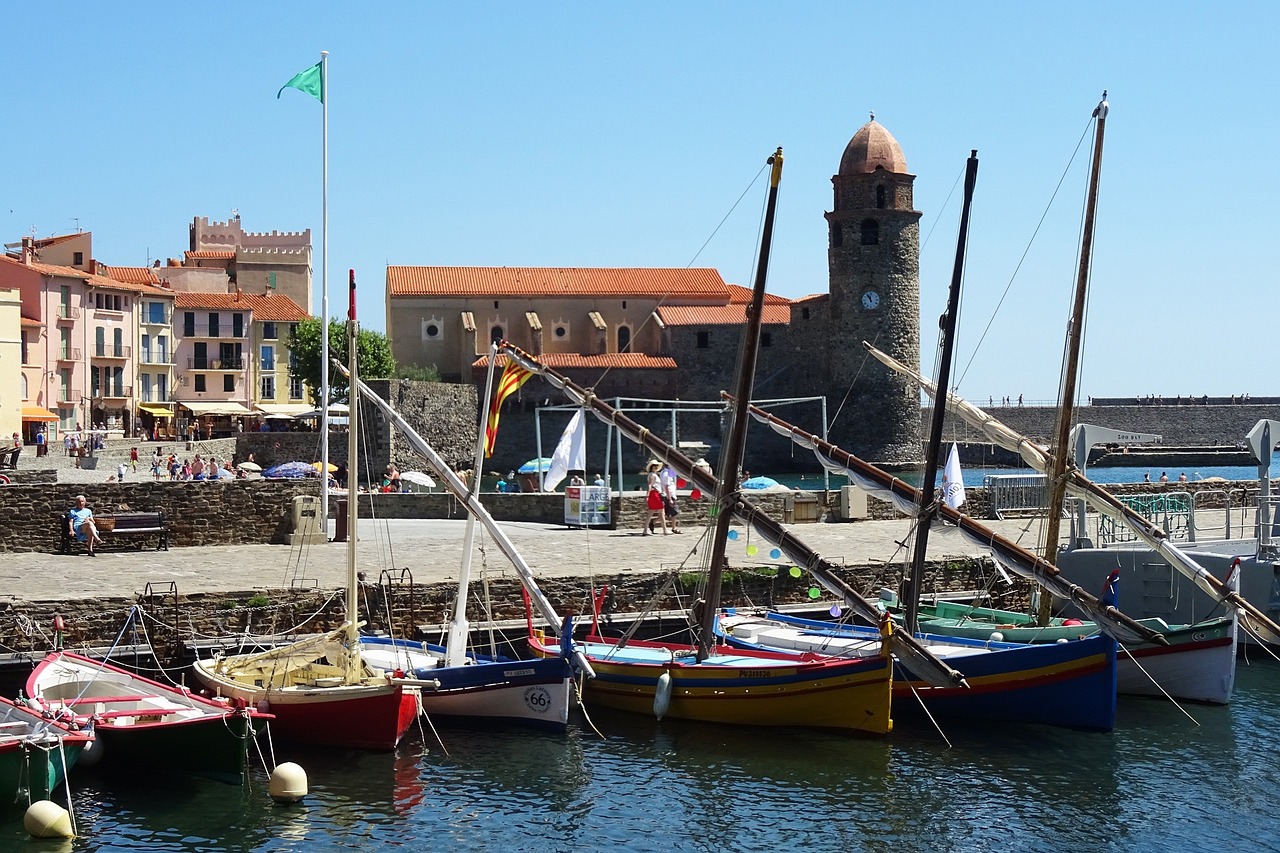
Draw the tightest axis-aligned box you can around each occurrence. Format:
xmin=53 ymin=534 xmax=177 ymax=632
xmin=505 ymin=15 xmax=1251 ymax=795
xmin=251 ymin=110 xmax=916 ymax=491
xmin=0 ymin=657 xmax=1280 ymax=853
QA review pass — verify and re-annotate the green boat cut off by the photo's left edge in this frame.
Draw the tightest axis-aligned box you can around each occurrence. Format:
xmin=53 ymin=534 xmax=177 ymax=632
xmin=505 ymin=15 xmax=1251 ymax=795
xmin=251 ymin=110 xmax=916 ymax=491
xmin=0 ymin=698 xmax=93 ymax=808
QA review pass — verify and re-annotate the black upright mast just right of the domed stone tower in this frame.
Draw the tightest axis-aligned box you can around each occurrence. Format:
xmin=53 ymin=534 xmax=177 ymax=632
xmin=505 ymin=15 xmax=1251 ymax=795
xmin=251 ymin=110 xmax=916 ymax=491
xmin=905 ymin=149 xmax=978 ymax=634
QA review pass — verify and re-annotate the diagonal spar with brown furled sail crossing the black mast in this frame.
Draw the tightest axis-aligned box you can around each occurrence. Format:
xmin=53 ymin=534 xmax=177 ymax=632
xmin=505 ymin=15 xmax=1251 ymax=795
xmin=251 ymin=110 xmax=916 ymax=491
xmin=749 ymin=406 xmax=1169 ymax=646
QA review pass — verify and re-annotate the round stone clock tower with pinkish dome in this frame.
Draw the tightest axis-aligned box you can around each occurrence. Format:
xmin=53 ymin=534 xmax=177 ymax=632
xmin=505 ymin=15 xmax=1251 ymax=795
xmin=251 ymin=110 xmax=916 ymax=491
xmin=826 ymin=114 xmax=920 ymax=462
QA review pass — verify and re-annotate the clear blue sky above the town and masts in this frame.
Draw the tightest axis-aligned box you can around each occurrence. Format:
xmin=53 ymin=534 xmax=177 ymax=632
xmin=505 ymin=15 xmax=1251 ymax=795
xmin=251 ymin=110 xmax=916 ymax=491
xmin=0 ymin=0 xmax=1280 ymax=402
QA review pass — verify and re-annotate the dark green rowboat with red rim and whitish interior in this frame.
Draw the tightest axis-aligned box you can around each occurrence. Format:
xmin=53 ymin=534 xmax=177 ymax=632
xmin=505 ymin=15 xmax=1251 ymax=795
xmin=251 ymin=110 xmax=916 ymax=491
xmin=27 ymin=652 xmax=268 ymax=784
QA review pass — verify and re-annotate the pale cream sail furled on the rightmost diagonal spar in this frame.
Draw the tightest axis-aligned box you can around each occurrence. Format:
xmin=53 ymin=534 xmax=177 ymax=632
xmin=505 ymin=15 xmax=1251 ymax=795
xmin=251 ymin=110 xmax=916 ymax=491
xmin=863 ymin=342 xmax=1280 ymax=635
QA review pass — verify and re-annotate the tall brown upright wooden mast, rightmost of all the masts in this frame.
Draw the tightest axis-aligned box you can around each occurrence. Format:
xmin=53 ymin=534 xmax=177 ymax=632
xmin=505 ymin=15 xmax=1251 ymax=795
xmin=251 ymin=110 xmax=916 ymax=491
xmin=1044 ymin=91 xmax=1108 ymax=625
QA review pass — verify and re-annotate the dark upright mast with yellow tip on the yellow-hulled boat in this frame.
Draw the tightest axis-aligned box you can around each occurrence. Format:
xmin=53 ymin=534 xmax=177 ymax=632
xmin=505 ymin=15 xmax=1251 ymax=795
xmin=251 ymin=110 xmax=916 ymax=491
xmin=698 ymin=147 xmax=782 ymax=661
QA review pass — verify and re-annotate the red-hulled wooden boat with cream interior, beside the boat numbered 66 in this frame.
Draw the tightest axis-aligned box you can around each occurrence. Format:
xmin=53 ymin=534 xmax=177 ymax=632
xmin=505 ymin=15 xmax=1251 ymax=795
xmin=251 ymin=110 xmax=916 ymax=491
xmin=193 ymin=661 xmax=419 ymax=751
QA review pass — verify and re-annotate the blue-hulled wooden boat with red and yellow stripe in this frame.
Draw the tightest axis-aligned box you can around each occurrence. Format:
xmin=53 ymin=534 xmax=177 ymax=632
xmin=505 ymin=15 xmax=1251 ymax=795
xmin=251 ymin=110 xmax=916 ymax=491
xmin=726 ymin=613 xmax=1116 ymax=731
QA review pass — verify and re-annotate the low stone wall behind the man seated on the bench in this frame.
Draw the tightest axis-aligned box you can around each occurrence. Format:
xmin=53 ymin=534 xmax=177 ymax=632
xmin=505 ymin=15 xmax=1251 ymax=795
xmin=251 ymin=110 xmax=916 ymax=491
xmin=0 ymin=479 xmax=315 ymax=552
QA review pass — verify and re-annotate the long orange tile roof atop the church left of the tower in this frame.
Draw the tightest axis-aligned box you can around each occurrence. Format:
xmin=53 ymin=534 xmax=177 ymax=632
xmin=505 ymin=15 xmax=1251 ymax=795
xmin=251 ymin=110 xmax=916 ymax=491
xmin=387 ymin=266 xmax=728 ymax=300
